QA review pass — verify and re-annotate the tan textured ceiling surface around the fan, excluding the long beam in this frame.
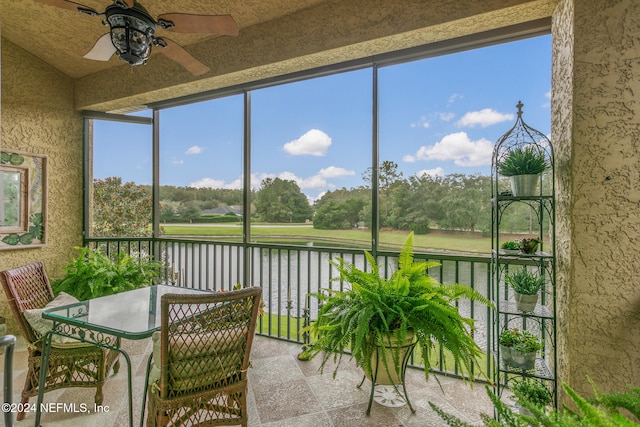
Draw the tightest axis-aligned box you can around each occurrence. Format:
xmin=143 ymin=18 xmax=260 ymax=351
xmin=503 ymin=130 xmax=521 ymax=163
xmin=0 ymin=0 xmax=326 ymax=78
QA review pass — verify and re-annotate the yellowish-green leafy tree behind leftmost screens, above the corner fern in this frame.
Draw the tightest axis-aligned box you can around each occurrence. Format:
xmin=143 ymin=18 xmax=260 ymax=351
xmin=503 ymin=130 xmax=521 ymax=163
xmin=91 ymin=177 xmax=152 ymax=237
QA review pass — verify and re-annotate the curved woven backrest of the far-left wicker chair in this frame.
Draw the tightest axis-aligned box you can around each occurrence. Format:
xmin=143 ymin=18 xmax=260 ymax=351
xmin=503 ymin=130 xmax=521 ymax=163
xmin=0 ymin=262 xmax=53 ymax=343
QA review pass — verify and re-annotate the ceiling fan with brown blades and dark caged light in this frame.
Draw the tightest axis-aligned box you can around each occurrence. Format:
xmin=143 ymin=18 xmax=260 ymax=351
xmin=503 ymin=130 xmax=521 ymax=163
xmin=36 ymin=0 xmax=238 ymax=75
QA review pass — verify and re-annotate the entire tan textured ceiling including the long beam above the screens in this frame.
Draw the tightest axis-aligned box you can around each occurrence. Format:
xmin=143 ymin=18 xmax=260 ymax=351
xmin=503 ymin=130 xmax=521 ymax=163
xmin=0 ymin=0 xmax=558 ymax=112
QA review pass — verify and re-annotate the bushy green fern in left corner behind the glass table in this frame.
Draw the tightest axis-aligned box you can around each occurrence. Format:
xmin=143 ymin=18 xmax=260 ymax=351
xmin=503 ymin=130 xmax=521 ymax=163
xmin=52 ymin=247 xmax=160 ymax=301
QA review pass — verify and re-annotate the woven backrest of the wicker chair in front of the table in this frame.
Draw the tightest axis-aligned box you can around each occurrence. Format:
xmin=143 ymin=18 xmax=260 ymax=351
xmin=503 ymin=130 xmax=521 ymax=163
xmin=160 ymin=287 xmax=262 ymax=398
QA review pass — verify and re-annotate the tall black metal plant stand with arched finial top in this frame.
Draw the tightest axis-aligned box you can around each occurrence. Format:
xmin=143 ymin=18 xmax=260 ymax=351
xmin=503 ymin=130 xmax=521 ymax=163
xmin=491 ymin=102 xmax=558 ymax=407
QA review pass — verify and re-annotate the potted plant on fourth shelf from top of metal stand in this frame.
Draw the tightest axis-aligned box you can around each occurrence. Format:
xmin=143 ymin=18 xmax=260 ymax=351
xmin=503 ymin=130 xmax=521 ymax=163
xmin=498 ymin=328 xmax=542 ymax=371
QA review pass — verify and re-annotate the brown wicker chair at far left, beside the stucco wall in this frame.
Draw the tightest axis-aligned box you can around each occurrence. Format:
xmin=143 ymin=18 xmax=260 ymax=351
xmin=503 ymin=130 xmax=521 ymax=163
xmin=0 ymin=262 xmax=119 ymax=421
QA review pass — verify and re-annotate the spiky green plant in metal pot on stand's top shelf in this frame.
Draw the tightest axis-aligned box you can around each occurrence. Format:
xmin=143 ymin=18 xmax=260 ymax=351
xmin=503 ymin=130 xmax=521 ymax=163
xmin=498 ymin=145 xmax=549 ymax=197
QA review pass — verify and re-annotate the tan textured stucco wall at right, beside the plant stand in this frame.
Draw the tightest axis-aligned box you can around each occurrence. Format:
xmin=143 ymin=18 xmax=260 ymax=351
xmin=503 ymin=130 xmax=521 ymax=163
xmin=552 ymin=0 xmax=640 ymax=393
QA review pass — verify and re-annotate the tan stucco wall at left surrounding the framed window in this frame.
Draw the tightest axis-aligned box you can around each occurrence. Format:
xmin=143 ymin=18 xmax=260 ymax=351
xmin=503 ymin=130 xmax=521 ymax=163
xmin=0 ymin=39 xmax=82 ymax=332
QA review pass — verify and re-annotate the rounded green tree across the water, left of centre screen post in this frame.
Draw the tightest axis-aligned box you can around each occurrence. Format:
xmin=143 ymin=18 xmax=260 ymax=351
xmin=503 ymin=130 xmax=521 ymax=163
xmin=255 ymin=178 xmax=312 ymax=222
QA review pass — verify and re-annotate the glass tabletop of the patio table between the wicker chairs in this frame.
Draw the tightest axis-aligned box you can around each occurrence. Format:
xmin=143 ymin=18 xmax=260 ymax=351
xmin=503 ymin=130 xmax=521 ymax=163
xmin=42 ymin=285 xmax=211 ymax=340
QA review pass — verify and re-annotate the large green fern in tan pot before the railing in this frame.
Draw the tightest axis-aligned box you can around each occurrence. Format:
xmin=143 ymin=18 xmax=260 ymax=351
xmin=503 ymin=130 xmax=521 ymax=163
xmin=305 ymin=233 xmax=491 ymax=398
